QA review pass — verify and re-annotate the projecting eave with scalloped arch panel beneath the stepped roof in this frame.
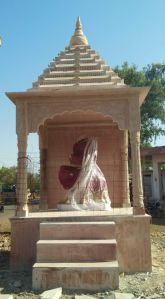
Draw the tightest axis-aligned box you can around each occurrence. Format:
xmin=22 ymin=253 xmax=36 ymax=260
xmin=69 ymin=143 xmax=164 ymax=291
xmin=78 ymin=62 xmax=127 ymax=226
xmin=7 ymin=86 xmax=148 ymax=133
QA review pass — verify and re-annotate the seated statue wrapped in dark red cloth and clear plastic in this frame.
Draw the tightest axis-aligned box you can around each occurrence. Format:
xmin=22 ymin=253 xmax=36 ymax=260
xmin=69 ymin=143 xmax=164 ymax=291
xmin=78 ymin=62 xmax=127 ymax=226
xmin=58 ymin=138 xmax=111 ymax=210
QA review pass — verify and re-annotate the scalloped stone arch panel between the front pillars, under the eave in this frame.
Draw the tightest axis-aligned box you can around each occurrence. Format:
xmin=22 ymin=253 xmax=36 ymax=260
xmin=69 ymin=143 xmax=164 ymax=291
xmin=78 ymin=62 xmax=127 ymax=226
xmin=28 ymin=100 xmax=128 ymax=132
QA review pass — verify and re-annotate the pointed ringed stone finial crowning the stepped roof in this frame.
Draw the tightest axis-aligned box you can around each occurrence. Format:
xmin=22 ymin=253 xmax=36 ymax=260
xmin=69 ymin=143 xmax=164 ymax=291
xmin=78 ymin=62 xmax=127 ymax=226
xmin=69 ymin=17 xmax=88 ymax=47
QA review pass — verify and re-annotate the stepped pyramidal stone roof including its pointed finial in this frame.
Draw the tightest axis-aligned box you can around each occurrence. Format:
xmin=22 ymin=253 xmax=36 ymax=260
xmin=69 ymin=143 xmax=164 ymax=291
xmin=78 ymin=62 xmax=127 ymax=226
xmin=30 ymin=17 xmax=126 ymax=90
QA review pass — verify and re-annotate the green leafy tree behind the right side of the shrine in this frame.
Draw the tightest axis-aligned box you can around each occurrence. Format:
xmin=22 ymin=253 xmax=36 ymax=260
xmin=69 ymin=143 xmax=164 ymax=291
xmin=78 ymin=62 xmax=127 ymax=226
xmin=115 ymin=62 xmax=165 ymax=146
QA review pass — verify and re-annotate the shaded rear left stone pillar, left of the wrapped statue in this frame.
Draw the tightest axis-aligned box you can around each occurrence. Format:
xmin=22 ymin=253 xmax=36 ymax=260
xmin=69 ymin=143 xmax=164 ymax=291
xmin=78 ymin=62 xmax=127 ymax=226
xmin=39 ymin=128 xmax=48 ymax=210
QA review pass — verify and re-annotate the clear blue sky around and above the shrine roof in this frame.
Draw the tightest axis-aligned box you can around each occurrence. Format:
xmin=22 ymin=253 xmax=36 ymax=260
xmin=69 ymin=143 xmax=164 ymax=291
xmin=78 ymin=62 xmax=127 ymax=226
xmin=0 ymin=0 xmax=165 ymax=167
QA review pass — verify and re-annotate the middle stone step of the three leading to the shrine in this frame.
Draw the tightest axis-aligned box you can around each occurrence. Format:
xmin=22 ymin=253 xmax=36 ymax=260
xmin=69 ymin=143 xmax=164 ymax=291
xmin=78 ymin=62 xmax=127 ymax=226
xmin=37 ymin=239 xmax=116 ymax=263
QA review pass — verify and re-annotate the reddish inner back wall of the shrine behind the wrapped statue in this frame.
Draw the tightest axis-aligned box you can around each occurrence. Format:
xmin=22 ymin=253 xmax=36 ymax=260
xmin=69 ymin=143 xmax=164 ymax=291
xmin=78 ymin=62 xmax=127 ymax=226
xmin=38 ymin=111 xmax=129 ymax=209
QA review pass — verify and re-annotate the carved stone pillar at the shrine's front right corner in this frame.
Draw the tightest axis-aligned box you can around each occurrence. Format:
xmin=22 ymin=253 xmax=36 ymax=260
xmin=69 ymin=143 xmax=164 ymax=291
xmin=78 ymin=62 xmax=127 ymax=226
xmin=130 ymin=131 xmax=145 ymax=214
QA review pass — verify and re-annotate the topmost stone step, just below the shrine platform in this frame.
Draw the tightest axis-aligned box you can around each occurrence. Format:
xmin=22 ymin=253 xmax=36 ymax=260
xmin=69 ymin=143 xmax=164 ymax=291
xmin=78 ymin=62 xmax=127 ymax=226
xmin=40 ymin=221 xmax=115 ymax=240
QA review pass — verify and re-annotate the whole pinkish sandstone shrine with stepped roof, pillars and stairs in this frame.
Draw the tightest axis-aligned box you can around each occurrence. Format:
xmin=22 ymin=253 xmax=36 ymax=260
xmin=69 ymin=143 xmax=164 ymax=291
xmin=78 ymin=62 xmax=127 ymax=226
xmin=7 ymin=18 xmax=151 ymax=289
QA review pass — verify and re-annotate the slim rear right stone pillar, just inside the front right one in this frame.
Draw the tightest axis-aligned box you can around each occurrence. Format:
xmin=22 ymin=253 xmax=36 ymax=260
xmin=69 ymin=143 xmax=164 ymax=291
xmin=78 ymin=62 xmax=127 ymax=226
xmin=121 ymin=130 xmax=131 ymax=207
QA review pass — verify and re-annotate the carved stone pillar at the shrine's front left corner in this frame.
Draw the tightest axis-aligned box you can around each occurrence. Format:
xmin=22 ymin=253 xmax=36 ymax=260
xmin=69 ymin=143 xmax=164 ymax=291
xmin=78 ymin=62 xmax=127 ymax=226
xmin=16 ymin=103 xmax=28 ymax=217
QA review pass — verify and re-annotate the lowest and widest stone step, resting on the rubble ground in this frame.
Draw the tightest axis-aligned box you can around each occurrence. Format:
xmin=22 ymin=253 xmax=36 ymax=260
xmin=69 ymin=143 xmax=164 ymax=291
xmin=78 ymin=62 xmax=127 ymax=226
xmin=32 ymin=261 xmax=119 ymax=292
